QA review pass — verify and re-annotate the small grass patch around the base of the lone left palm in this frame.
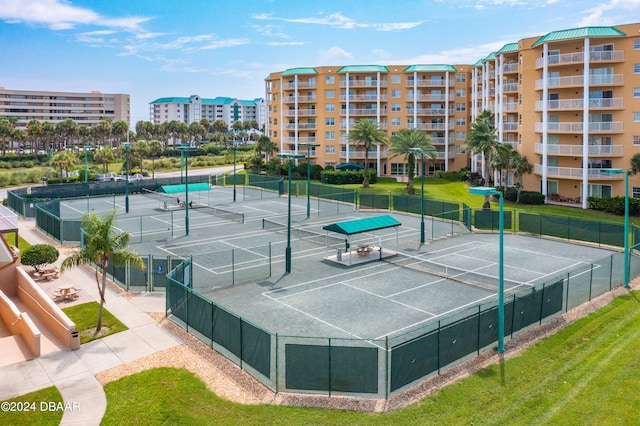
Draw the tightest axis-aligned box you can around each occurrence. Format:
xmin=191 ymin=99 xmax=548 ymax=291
xmin=63 ymin=302 xmax=127 ymax=344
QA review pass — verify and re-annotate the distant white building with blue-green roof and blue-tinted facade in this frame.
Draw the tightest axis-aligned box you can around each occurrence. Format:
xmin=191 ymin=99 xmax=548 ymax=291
xmin=149 ymin=95 xmax=267 ymax=129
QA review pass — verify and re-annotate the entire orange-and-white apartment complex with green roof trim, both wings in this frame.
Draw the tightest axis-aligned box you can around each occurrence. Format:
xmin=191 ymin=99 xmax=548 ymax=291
xmin=265 ymin=24 xmax=640 ymax=208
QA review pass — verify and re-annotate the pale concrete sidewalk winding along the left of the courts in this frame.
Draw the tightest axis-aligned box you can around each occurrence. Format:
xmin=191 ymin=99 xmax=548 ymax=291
xmin=0 ymin=219 xmax=182 ymax=425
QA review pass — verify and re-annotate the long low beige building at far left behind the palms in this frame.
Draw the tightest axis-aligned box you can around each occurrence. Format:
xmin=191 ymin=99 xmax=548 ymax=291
xmin=0 ymin=87 xmax=130 ymax=129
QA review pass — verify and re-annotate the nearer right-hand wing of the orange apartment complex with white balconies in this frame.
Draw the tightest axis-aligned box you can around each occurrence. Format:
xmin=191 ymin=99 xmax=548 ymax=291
xmin=472 ymin=24 xmax=640 ymax=208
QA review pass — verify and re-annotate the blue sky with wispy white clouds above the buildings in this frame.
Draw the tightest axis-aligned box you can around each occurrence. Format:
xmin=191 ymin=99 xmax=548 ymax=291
xmin=0 ymin=0 xmax=640 ymax=126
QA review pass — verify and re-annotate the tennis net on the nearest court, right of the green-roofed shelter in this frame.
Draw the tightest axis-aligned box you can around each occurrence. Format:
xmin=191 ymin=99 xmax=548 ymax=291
xmin=382 ymin=253 xmax=533 ymax=291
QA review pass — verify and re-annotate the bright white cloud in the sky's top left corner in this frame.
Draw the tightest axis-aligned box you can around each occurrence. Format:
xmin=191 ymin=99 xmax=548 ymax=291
xmin=0 ymin=0 xmax=150 ymax=30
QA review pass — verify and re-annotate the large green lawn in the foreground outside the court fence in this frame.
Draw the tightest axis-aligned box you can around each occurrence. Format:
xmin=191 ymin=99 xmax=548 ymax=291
xmin=104 ymin=292 xmax=640 ymax=425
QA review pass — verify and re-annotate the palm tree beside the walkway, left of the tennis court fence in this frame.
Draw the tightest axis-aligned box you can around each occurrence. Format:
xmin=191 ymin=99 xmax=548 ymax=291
xmin=60 ymin=211 xmax=145 ymax=335
